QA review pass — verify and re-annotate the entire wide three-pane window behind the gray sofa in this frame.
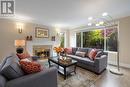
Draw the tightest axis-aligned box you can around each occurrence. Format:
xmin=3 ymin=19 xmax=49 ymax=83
xmin=76 ymin=28 xmax=118 ymax=51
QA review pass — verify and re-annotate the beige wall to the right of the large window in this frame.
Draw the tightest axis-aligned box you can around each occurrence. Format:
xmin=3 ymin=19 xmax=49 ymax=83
xmin=119 ymin=16 xmax=130 ymax=67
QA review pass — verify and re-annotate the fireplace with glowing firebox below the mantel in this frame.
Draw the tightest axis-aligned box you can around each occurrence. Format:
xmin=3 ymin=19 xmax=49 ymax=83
xmin=33 ymin=45 xmax=52 ymax=58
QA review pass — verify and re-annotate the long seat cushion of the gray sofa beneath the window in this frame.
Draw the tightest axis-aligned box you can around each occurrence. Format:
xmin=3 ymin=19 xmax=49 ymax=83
xmin=67 ymin=55 xmax=94 ymax=66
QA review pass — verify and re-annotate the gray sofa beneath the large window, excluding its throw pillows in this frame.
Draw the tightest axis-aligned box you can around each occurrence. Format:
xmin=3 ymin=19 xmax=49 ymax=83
xmin=67 ymin=48 xmax=107 ymax=74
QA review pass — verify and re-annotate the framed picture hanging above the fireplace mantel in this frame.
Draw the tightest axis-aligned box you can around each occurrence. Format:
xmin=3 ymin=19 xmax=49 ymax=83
xmin=35 ymin=27 xmax=49 ymax=38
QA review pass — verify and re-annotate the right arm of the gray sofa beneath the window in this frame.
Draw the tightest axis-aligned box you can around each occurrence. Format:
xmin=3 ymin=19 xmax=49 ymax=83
xmin=94 ymin=55 xmax=107 ymax=73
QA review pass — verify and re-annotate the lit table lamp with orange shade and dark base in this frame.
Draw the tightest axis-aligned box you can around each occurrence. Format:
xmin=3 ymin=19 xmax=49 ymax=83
xmin=15 ymin=40 xmax=25 ymax=54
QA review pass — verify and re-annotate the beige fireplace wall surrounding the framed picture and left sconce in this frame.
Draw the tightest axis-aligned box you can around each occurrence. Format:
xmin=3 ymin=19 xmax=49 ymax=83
xmin=0 ymin=19 xmax=65 ymax=61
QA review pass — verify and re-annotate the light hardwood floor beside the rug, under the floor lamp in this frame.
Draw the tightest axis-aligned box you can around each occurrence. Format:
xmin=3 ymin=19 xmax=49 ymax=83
xmin=95 ymin=66 xmax=130 ymax=87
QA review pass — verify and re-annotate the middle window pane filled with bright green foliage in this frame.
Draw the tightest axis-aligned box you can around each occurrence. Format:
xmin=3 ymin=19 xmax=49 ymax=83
xmin=83 ymin=30 xmax=104 ymax=49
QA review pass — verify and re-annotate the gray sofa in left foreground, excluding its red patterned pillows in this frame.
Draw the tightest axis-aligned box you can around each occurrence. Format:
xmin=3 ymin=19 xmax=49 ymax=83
xmin=0 ymin=54 xmax=57 ymax=87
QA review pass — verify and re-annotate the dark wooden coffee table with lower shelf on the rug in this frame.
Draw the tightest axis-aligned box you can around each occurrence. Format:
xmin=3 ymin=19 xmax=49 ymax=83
xmin=48 ymin=56 xmax=77 ymax=79
